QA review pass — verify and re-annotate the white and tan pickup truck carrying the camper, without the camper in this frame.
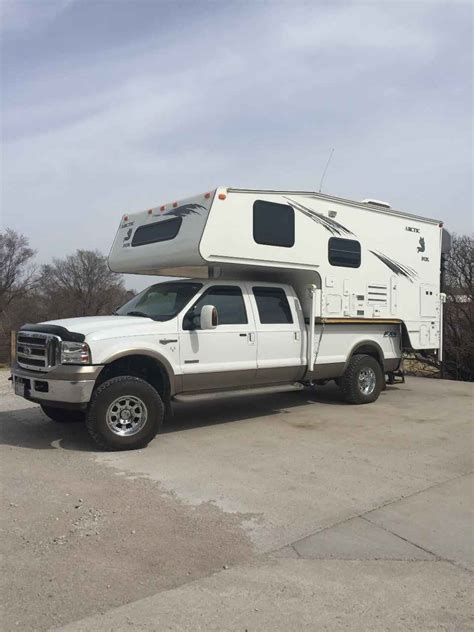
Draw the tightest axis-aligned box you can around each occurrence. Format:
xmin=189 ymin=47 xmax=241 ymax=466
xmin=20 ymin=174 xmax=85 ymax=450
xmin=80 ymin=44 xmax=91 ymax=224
xmin=12 ymin=280 xmax=401 ymax=450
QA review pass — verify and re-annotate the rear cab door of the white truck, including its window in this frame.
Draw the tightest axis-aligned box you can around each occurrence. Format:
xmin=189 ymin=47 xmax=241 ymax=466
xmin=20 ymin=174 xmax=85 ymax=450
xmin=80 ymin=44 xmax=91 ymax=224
xmin=248 ymin=283 xmax=306 ymax=384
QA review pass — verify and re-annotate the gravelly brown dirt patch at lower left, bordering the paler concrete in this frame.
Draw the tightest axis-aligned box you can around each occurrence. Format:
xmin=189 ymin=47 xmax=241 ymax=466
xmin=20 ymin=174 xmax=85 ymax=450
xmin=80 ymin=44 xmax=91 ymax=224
xmin=0 ymin=408 xmax=252 ymax=631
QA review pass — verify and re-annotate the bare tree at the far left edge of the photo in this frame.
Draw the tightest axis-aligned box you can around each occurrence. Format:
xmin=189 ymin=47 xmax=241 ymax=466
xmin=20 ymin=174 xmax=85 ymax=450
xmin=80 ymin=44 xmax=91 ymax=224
xmin=0 ymin=228 xmax=35 ymax=310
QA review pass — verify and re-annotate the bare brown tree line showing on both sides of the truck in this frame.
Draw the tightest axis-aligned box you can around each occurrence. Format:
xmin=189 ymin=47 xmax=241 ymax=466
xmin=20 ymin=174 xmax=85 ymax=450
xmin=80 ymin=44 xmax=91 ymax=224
xmin=0 ymin=228 xmax=474 ymax=381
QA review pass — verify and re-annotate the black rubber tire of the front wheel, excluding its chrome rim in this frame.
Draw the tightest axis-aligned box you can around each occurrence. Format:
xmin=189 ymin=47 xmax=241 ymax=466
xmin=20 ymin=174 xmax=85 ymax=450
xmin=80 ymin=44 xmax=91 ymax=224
xmin=86 ymin=375 xmax=165 ymax=451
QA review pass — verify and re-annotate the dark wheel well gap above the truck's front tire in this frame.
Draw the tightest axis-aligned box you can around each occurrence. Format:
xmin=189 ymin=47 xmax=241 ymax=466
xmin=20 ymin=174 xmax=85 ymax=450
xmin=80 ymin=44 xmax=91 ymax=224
xmin=96 ymin=355 xmax=170 ymax=403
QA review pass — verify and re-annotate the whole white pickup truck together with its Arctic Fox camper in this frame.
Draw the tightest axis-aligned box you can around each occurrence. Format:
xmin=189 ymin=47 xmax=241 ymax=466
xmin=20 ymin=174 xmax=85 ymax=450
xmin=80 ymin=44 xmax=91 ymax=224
xmin=12 ymin=188 xmax=450 ymax=450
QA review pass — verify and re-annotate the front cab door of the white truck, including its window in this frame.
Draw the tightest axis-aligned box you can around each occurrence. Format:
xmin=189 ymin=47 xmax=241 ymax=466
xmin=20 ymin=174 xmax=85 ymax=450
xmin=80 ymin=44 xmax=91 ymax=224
xmin=179 ymin=282 xmax=257 ymax=392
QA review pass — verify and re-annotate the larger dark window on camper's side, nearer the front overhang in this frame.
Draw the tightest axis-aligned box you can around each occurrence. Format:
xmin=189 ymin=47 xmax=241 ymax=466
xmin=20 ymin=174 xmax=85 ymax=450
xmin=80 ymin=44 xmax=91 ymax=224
xmin=253 ymin=200 xmax=295 ymax=248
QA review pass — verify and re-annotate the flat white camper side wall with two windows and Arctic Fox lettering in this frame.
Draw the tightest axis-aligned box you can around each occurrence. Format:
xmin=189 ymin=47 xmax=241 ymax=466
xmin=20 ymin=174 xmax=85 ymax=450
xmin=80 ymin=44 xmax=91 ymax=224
xmin=200 ymin=191 xmax=441 ymax=349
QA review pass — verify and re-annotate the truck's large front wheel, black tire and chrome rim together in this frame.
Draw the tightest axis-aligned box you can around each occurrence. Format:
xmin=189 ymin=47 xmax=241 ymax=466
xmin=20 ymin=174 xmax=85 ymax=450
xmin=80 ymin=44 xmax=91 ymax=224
xmin=86 ymin=375 xmax=164 ymax=450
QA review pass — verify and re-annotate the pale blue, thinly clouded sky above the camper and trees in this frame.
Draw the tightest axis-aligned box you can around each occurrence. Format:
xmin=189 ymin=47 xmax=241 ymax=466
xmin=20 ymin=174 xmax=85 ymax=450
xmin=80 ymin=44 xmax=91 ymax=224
xmin=0 ymin=0 xmax=473 ymax=287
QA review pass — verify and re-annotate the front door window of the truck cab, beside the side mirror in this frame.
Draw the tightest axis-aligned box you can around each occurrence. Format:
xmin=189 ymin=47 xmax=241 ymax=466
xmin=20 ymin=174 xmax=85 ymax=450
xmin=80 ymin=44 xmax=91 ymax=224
xmin=183 ymin=285 xmax=248 ymax=330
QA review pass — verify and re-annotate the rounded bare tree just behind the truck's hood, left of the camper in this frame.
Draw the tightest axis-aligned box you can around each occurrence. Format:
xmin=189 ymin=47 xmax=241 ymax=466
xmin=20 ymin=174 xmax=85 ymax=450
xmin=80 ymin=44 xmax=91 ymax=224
xmin=39 ymin=250 xmax=129 ymax=318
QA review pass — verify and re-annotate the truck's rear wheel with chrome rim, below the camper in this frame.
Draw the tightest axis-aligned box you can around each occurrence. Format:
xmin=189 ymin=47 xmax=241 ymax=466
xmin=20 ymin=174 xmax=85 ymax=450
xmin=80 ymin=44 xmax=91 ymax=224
xmin=339 ymin=354 xmax=384 ymax=404
